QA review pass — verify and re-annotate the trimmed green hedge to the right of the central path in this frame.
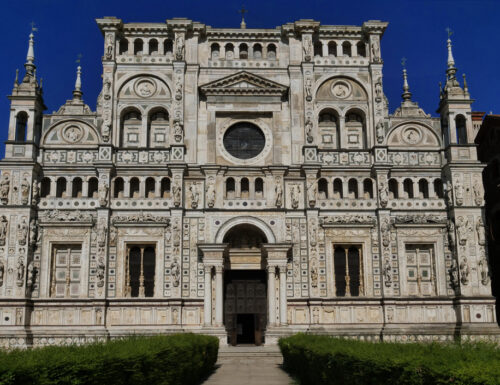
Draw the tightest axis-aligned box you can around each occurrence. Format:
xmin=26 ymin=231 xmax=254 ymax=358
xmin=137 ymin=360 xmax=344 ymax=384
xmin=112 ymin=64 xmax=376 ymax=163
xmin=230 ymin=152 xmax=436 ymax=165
xmin=279 ymin=334 xmax=500 ymax=385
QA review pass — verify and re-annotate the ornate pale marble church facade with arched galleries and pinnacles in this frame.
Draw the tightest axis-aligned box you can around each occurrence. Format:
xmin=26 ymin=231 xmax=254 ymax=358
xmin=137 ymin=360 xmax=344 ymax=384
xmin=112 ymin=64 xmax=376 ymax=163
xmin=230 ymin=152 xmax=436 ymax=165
xmin=0 ymin=17 xmax=499 ymax=347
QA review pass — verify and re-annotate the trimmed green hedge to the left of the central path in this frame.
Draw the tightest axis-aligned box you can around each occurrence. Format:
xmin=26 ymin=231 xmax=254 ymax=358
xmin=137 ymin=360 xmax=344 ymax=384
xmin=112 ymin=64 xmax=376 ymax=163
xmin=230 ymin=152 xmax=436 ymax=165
xmin=0 ymin=334 xmax=219 ymax=385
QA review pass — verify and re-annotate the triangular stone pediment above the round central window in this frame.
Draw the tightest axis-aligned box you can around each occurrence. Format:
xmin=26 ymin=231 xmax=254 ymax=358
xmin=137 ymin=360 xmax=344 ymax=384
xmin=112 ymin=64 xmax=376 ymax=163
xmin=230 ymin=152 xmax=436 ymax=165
xmin=200 ymin=71 xmax=288 ymax=96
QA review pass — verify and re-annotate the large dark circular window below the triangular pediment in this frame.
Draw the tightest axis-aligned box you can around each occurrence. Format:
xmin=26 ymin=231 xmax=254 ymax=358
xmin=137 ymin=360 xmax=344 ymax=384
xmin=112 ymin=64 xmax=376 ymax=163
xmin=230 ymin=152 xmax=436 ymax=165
xmin=224 ymin=122 xmax=266 ymax=159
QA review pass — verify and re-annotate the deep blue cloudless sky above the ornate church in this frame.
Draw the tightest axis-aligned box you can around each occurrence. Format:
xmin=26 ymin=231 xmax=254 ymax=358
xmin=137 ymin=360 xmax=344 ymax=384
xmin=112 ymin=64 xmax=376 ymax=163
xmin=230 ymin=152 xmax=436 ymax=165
xmin=0 ymin=0 xmax=500 ymax=156
